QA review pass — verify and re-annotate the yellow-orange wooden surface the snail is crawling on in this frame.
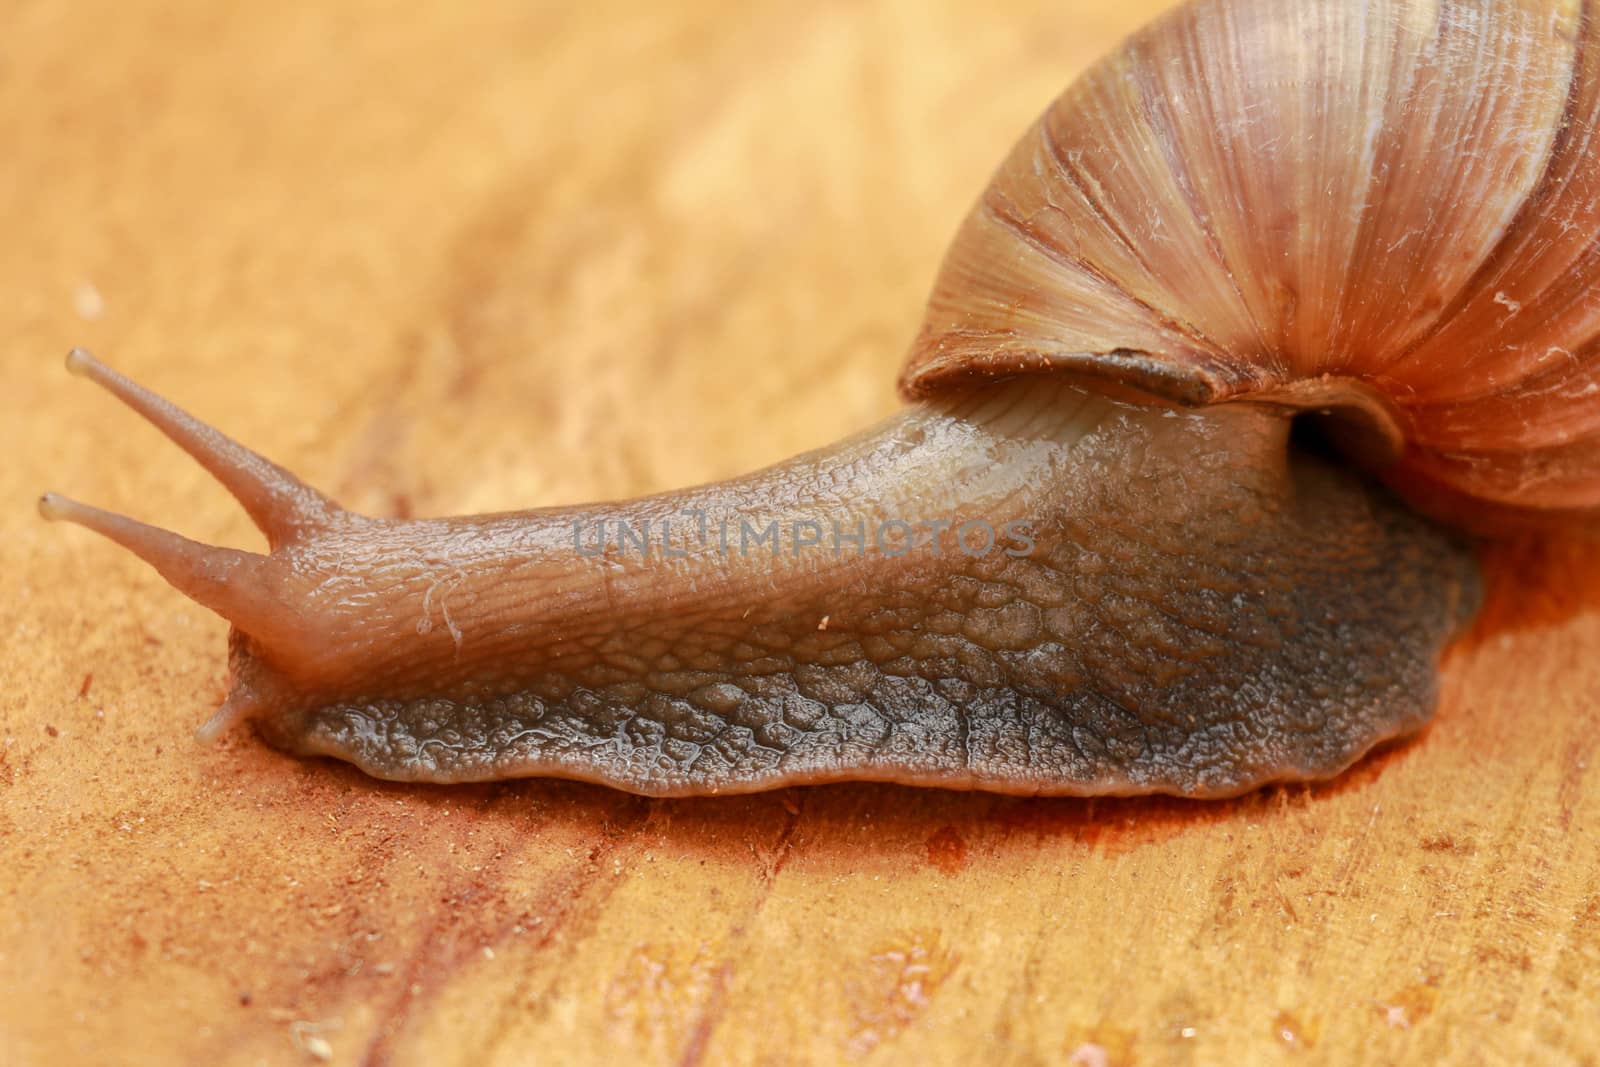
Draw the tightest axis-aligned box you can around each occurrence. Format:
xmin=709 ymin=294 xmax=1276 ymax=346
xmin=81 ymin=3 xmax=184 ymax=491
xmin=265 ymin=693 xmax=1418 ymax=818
xmin=0 ymin=0 xmax=1600 ymax=1065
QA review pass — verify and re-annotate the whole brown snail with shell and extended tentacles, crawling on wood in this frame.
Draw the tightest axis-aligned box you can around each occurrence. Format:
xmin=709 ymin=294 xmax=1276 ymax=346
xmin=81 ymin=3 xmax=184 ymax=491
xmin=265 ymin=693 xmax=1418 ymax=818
xmin=40 ymin=0 xmax=1600 ymax=797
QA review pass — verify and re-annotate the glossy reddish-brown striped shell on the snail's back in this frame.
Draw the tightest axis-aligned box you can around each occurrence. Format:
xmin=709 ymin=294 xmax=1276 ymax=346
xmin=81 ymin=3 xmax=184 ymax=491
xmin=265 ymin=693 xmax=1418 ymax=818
xmin=901 ymin=0 xmax=1600 ymax=518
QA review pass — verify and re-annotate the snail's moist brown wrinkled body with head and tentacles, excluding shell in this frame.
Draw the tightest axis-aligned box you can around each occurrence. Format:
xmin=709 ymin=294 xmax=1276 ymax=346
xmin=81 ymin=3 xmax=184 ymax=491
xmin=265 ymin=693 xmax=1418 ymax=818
xmin=42 ymin=352 xmax=1478 ymax=797
